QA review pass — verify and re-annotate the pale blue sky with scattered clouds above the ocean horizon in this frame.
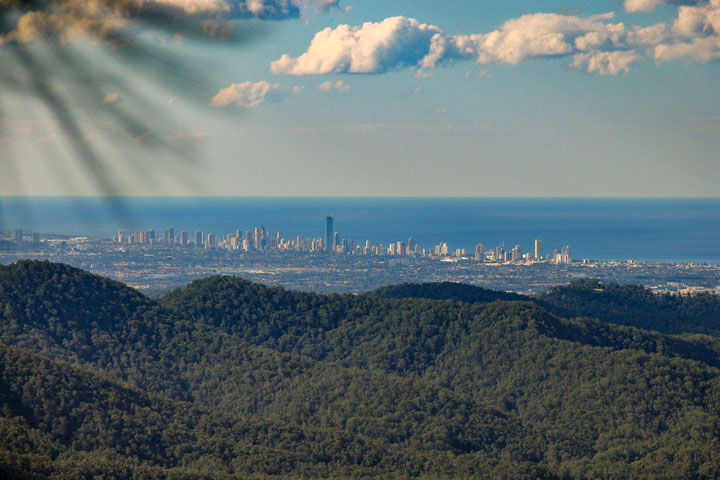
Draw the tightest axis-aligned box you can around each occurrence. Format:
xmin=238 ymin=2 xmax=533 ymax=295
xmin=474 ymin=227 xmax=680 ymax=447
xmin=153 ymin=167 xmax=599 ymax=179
xmin=0 ymin=0 xmax=720 ymax=197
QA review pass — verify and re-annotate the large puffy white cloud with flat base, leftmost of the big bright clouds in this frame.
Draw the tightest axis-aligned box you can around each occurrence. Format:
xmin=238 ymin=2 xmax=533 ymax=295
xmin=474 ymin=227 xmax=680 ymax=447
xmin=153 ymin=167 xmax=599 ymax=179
xmin=270 ymin=17 xmax=440 ymax=75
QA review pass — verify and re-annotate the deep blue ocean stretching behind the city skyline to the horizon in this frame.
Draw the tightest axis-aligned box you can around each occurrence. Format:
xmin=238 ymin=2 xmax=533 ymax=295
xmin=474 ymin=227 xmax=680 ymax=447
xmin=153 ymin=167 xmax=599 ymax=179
xmin=0 ymin=197 xmax=720 ymax=265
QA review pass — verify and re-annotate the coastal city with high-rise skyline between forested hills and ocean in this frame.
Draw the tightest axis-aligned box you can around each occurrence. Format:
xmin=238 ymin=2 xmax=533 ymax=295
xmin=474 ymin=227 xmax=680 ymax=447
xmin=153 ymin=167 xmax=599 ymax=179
xmin=0 ymin=216 xmax=720 ymax=294
